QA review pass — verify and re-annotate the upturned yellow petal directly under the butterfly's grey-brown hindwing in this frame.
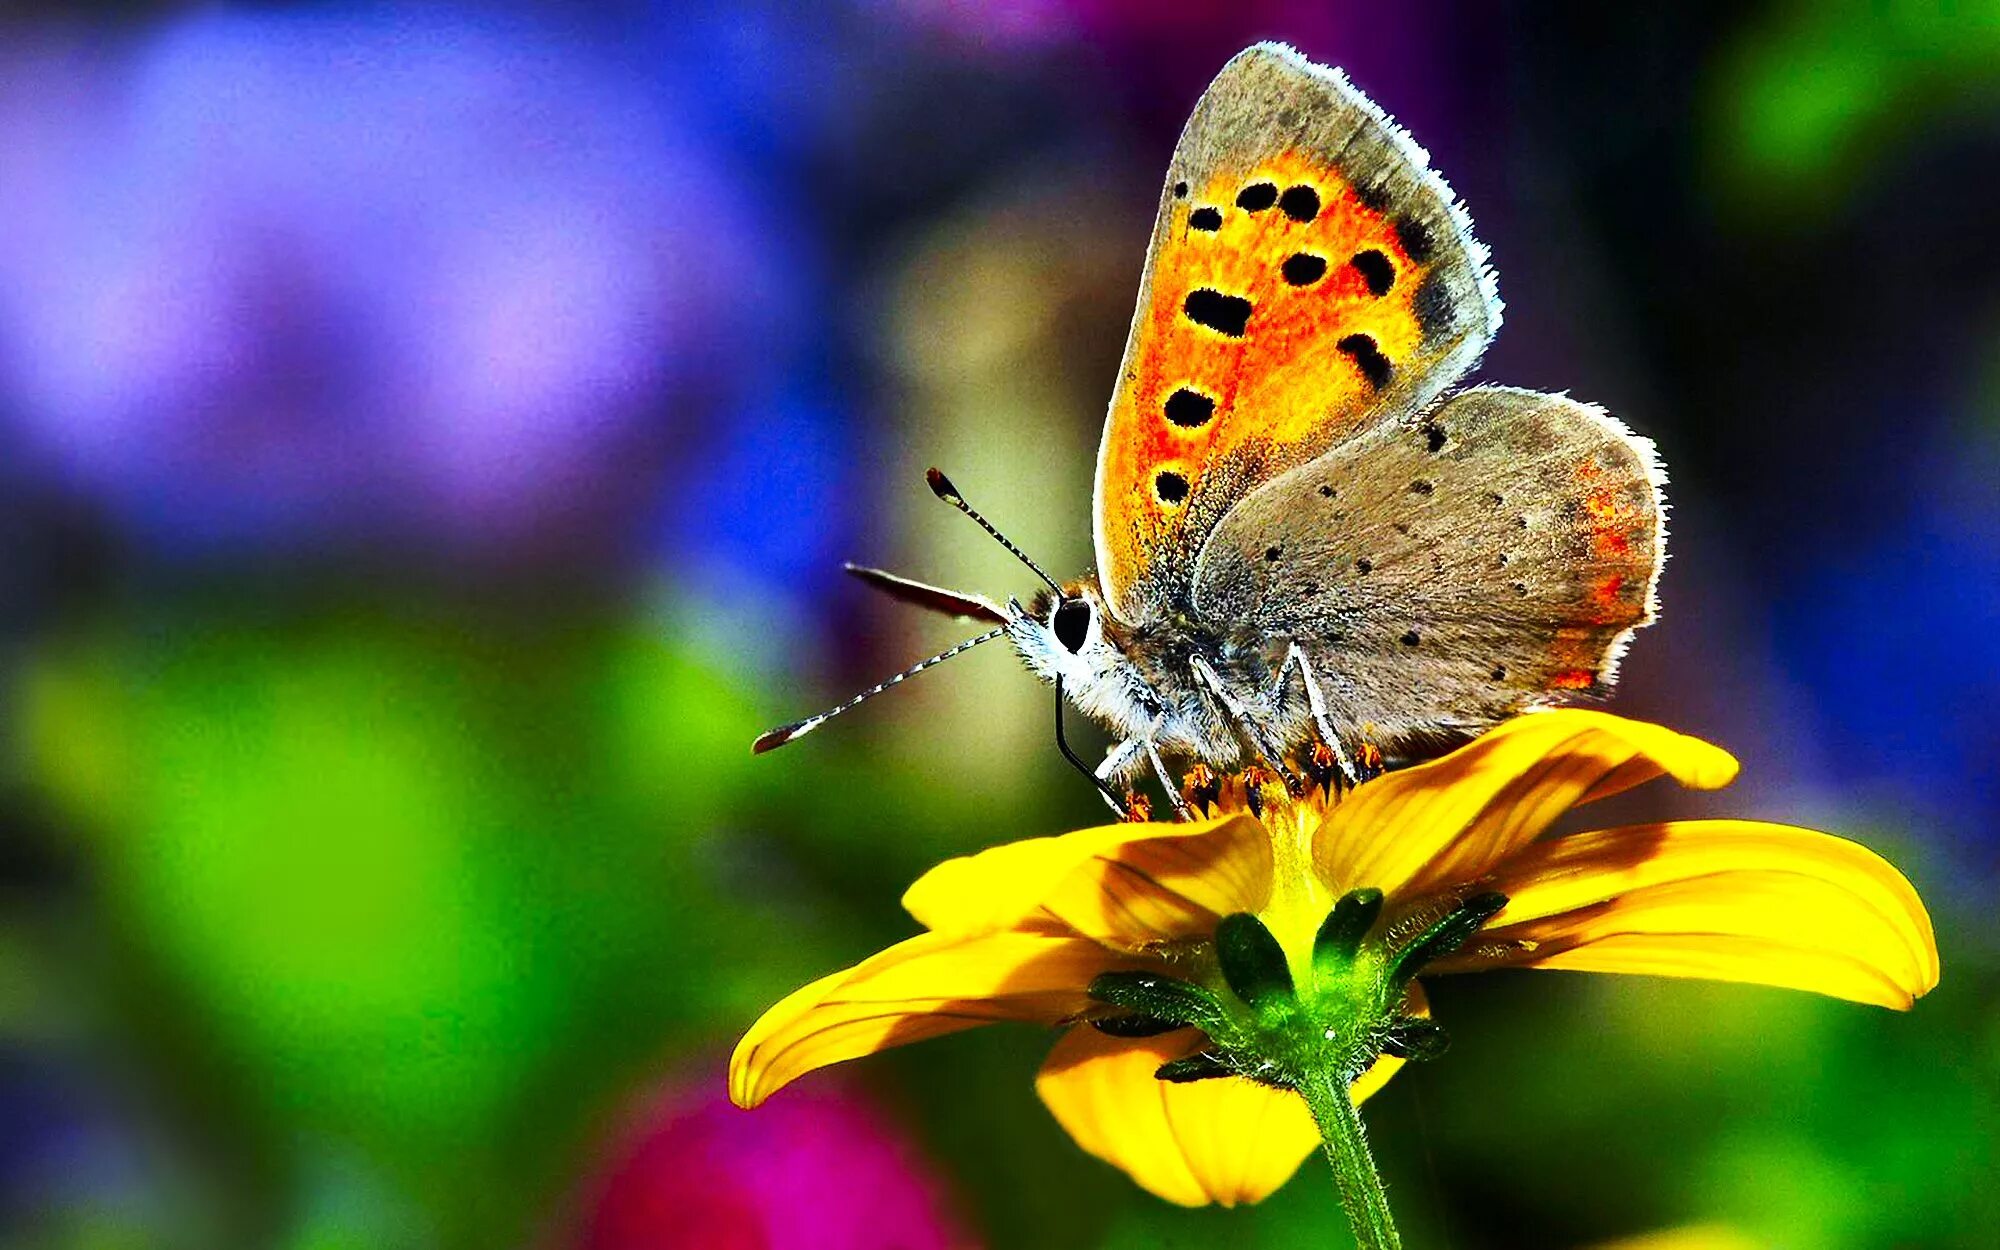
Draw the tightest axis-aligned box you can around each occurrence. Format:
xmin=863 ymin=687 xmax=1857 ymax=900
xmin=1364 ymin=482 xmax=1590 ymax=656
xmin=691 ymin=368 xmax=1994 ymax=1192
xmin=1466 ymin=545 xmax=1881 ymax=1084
xmin=1314 ymin=708 xmax=1736 ymax=896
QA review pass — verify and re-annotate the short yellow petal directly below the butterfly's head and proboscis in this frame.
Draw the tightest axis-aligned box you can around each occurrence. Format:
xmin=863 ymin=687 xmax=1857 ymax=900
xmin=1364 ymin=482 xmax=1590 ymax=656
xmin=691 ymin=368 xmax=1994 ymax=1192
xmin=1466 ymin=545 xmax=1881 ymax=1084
xmin=902 ymin=816 xmax=1270 ymax=946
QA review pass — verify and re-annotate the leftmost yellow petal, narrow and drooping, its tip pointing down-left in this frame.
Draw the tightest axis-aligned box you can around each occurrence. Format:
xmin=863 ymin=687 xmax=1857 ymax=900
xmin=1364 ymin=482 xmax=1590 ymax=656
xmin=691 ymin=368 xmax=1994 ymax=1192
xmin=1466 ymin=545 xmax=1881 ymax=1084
xmin=730 ymin=934 xmax=1132 ymax=1106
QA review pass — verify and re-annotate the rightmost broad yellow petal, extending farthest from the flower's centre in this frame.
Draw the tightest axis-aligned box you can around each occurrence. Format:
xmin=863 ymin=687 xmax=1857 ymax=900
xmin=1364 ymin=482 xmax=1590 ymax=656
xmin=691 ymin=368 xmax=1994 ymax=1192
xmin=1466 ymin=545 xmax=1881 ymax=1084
xmin=1436 ymin=820 xmax=1938 ymax=1010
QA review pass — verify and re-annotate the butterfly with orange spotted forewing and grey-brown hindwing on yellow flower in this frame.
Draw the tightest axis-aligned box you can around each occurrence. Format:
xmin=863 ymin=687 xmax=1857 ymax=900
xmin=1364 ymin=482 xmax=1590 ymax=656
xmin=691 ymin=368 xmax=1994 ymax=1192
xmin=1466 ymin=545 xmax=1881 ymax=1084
xmin=756 ymin=44 xmax=1666 ymax=814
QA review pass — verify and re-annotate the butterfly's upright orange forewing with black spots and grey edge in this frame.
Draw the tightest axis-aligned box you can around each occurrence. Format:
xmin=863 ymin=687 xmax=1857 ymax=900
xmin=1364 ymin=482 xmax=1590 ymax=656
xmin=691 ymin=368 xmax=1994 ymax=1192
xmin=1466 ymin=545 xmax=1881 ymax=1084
xmin=1092 ymin=44 xmax=1500 ymax=622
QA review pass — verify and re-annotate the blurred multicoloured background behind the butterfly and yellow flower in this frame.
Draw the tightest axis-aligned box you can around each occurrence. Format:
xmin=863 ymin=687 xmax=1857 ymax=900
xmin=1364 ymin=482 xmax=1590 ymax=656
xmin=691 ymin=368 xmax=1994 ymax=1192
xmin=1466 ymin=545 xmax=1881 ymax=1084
xmin=0 ymin=0 xmax=2000 ymax=1250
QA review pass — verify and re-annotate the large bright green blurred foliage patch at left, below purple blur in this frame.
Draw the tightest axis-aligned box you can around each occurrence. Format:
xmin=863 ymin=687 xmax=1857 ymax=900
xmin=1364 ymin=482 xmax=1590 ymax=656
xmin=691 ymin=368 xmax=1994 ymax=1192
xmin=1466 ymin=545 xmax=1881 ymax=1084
xmin=9 ymin=616 xmax=812 ymax=1244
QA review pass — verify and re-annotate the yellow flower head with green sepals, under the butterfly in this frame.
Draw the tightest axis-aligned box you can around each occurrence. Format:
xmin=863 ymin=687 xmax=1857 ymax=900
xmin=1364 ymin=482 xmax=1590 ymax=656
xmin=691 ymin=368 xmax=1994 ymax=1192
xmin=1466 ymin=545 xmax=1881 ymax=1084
xmin=730 ymin=710 xmax=1938 ymax=1206
